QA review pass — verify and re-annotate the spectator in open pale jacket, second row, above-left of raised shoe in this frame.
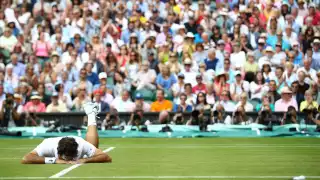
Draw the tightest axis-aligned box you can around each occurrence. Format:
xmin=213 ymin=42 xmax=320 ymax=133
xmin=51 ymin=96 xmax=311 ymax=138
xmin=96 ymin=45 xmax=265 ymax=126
xmin=72 ymin=68 xmax=93 ymax=96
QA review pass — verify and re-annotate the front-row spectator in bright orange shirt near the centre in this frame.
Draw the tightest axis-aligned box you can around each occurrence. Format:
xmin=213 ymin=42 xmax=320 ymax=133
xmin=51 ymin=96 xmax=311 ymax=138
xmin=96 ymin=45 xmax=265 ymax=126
xmin=151 ymin=89 xmax=173 ymax=124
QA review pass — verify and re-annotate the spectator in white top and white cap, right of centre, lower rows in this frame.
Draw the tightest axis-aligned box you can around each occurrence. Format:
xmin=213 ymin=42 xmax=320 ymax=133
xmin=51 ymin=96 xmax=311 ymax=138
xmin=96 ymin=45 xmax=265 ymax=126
xmin=230 ymin=71 xmax=250 ymax=101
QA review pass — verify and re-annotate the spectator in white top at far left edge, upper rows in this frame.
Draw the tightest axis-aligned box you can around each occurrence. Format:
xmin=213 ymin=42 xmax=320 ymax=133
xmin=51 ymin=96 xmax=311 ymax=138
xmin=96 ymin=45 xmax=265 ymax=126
xmin=0 ymin=27 xmax=18 ymax=64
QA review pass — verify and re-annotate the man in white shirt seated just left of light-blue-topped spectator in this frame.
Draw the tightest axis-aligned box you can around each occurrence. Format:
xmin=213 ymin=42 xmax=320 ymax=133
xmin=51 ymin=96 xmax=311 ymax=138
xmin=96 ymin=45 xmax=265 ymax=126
xmin=132 ymin=61 xmax=157 ymax=90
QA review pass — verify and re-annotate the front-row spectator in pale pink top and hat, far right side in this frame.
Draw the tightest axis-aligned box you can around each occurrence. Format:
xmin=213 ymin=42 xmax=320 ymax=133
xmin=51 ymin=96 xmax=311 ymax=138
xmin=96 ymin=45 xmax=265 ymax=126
xmin=275 ymin=87 xmax=298 ymax=112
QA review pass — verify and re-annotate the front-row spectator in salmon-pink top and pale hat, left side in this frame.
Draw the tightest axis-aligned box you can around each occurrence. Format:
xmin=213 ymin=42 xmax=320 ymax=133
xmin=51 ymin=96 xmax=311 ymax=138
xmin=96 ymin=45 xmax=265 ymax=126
xmin=23 ymin=93 xmax=46 ymax=112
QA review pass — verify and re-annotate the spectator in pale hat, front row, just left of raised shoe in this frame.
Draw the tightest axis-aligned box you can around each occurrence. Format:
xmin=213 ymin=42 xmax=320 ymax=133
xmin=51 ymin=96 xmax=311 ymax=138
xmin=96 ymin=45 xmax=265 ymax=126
xmin=72 ymin=84 xmax=91 ymax=111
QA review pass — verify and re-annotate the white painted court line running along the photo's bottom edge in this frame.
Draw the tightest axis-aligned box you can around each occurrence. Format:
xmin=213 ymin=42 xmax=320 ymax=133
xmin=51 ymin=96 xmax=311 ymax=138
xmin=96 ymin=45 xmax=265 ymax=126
xmin=0 ymin=176 xmax=320 ymax=180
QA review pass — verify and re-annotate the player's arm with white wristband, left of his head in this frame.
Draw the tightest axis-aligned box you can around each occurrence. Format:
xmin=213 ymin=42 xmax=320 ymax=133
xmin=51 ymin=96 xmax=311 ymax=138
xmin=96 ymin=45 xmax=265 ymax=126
xmin=21 ymin=151 xmax=71 ymax=164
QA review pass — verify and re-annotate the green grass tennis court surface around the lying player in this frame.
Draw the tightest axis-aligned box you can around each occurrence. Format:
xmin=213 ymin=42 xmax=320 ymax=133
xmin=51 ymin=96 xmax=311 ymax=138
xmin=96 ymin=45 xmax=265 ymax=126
xmin=0 ymin=138 xmax=320 ymax=180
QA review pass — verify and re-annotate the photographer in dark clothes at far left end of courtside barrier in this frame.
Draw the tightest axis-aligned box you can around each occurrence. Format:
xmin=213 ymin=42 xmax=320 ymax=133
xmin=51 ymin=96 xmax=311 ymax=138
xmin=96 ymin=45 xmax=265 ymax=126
xmin=0 ymin=94 xmax=22 ymax=127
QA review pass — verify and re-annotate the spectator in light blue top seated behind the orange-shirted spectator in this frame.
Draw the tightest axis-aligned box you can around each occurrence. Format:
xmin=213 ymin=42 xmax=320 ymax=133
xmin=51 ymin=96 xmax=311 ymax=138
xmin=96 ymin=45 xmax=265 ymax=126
xmin=156 ymin=66 xmax=177 ymax=90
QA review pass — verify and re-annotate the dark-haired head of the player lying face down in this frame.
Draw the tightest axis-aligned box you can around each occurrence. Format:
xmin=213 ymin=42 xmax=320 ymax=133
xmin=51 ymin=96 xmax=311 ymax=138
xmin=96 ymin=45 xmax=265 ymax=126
xmin=58 ymin=137 xmax=78 ymax=161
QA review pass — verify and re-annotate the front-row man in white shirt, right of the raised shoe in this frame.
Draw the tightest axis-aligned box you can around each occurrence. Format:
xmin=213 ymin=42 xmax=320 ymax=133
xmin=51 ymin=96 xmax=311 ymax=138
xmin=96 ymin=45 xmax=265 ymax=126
xmin=110 ymin=90 xmax=134 ymax=112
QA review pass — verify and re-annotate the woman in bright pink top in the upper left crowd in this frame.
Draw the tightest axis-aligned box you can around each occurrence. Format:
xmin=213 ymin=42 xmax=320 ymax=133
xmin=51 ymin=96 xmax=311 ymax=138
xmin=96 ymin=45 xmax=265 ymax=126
xmin=32 ymin=32 xmax=51 ymax=67
